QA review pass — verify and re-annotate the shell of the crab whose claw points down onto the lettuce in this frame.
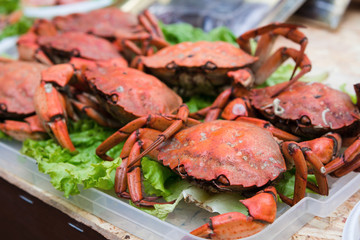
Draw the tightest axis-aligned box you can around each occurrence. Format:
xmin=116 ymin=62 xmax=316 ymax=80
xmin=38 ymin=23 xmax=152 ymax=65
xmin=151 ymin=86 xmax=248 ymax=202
xmin=84 ymin=67 xmax=182 ymax=124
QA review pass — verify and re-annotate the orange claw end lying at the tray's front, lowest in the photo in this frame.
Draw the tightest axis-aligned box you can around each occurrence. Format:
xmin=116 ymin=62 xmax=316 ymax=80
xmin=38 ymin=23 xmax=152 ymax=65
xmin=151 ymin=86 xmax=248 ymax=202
xmin=191 ymin=212 xmax=266 ymax=239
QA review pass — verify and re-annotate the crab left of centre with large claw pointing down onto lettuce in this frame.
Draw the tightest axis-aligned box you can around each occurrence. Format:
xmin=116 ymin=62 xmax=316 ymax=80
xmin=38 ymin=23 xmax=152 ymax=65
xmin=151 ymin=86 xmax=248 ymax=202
xmin=34 ymin=59 xmax=182 ymax=151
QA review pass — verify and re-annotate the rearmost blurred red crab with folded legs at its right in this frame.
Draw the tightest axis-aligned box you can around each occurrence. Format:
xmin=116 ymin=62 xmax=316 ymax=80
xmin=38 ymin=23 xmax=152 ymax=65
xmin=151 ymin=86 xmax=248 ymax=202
xmin=19 ymin=8 xmax=168 ymax=62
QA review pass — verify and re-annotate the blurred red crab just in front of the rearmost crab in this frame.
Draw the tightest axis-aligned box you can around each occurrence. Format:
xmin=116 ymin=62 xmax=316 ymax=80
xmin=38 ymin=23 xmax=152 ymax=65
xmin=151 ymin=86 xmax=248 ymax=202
xmin=17 ymin=28 xmax=127 ymax=66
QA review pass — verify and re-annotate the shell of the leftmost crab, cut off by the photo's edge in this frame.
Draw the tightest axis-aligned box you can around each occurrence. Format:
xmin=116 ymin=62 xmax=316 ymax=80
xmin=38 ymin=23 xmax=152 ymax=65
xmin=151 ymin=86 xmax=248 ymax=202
xmin=0 ymin=61 xmax=47 ymax=119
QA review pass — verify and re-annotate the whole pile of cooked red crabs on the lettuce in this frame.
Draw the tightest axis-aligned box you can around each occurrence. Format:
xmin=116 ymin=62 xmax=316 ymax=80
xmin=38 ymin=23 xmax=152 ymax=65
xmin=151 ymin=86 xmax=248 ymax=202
xmin=0 ymin=5 xmax=360 ymax=239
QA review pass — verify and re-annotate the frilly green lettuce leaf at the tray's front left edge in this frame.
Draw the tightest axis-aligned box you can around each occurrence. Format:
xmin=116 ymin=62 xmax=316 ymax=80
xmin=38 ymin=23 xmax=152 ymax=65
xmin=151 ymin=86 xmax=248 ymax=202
xmin=21 ymin=119 xmax=122 ymax=197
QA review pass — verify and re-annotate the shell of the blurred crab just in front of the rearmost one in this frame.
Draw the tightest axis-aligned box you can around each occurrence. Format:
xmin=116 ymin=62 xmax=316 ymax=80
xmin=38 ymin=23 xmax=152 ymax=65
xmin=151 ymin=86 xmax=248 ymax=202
xmin=37 ymin=32 xmax=125 ymax=63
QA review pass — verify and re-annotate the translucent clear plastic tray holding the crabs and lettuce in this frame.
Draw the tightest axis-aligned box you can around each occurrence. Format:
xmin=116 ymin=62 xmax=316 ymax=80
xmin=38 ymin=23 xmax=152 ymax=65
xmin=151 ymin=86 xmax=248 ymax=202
xmin=0 ymin=141 xmax=360 ymax=240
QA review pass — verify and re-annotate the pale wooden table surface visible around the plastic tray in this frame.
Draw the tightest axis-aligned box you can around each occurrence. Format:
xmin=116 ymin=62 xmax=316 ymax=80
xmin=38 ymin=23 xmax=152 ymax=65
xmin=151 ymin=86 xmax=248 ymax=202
xmin=0 ymin=4 xmax=360 ymax=240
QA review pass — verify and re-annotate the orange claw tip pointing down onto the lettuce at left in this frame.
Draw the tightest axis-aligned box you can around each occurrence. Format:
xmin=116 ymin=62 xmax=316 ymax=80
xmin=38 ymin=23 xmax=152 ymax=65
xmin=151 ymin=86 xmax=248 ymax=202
xmin=49 ymin=119 xmax=76 ymax=152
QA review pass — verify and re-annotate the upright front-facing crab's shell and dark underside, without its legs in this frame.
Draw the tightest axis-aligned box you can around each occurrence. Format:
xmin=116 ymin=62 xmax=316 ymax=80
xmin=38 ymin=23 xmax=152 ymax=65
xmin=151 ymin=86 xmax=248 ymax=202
xmin=141 ymin=41 xmax=257 ymax=97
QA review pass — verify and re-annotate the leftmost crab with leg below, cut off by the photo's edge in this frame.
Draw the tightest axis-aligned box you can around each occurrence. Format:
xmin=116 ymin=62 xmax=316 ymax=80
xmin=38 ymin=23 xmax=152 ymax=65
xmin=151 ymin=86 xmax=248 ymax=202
xmin=0 ymin=59 xmax=47 ymax=141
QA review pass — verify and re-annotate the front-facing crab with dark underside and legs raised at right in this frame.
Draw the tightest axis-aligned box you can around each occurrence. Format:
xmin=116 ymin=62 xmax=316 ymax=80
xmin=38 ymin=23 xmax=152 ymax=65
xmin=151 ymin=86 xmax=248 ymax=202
xmin=133 ymin=23 xmax=307 ymax=97
